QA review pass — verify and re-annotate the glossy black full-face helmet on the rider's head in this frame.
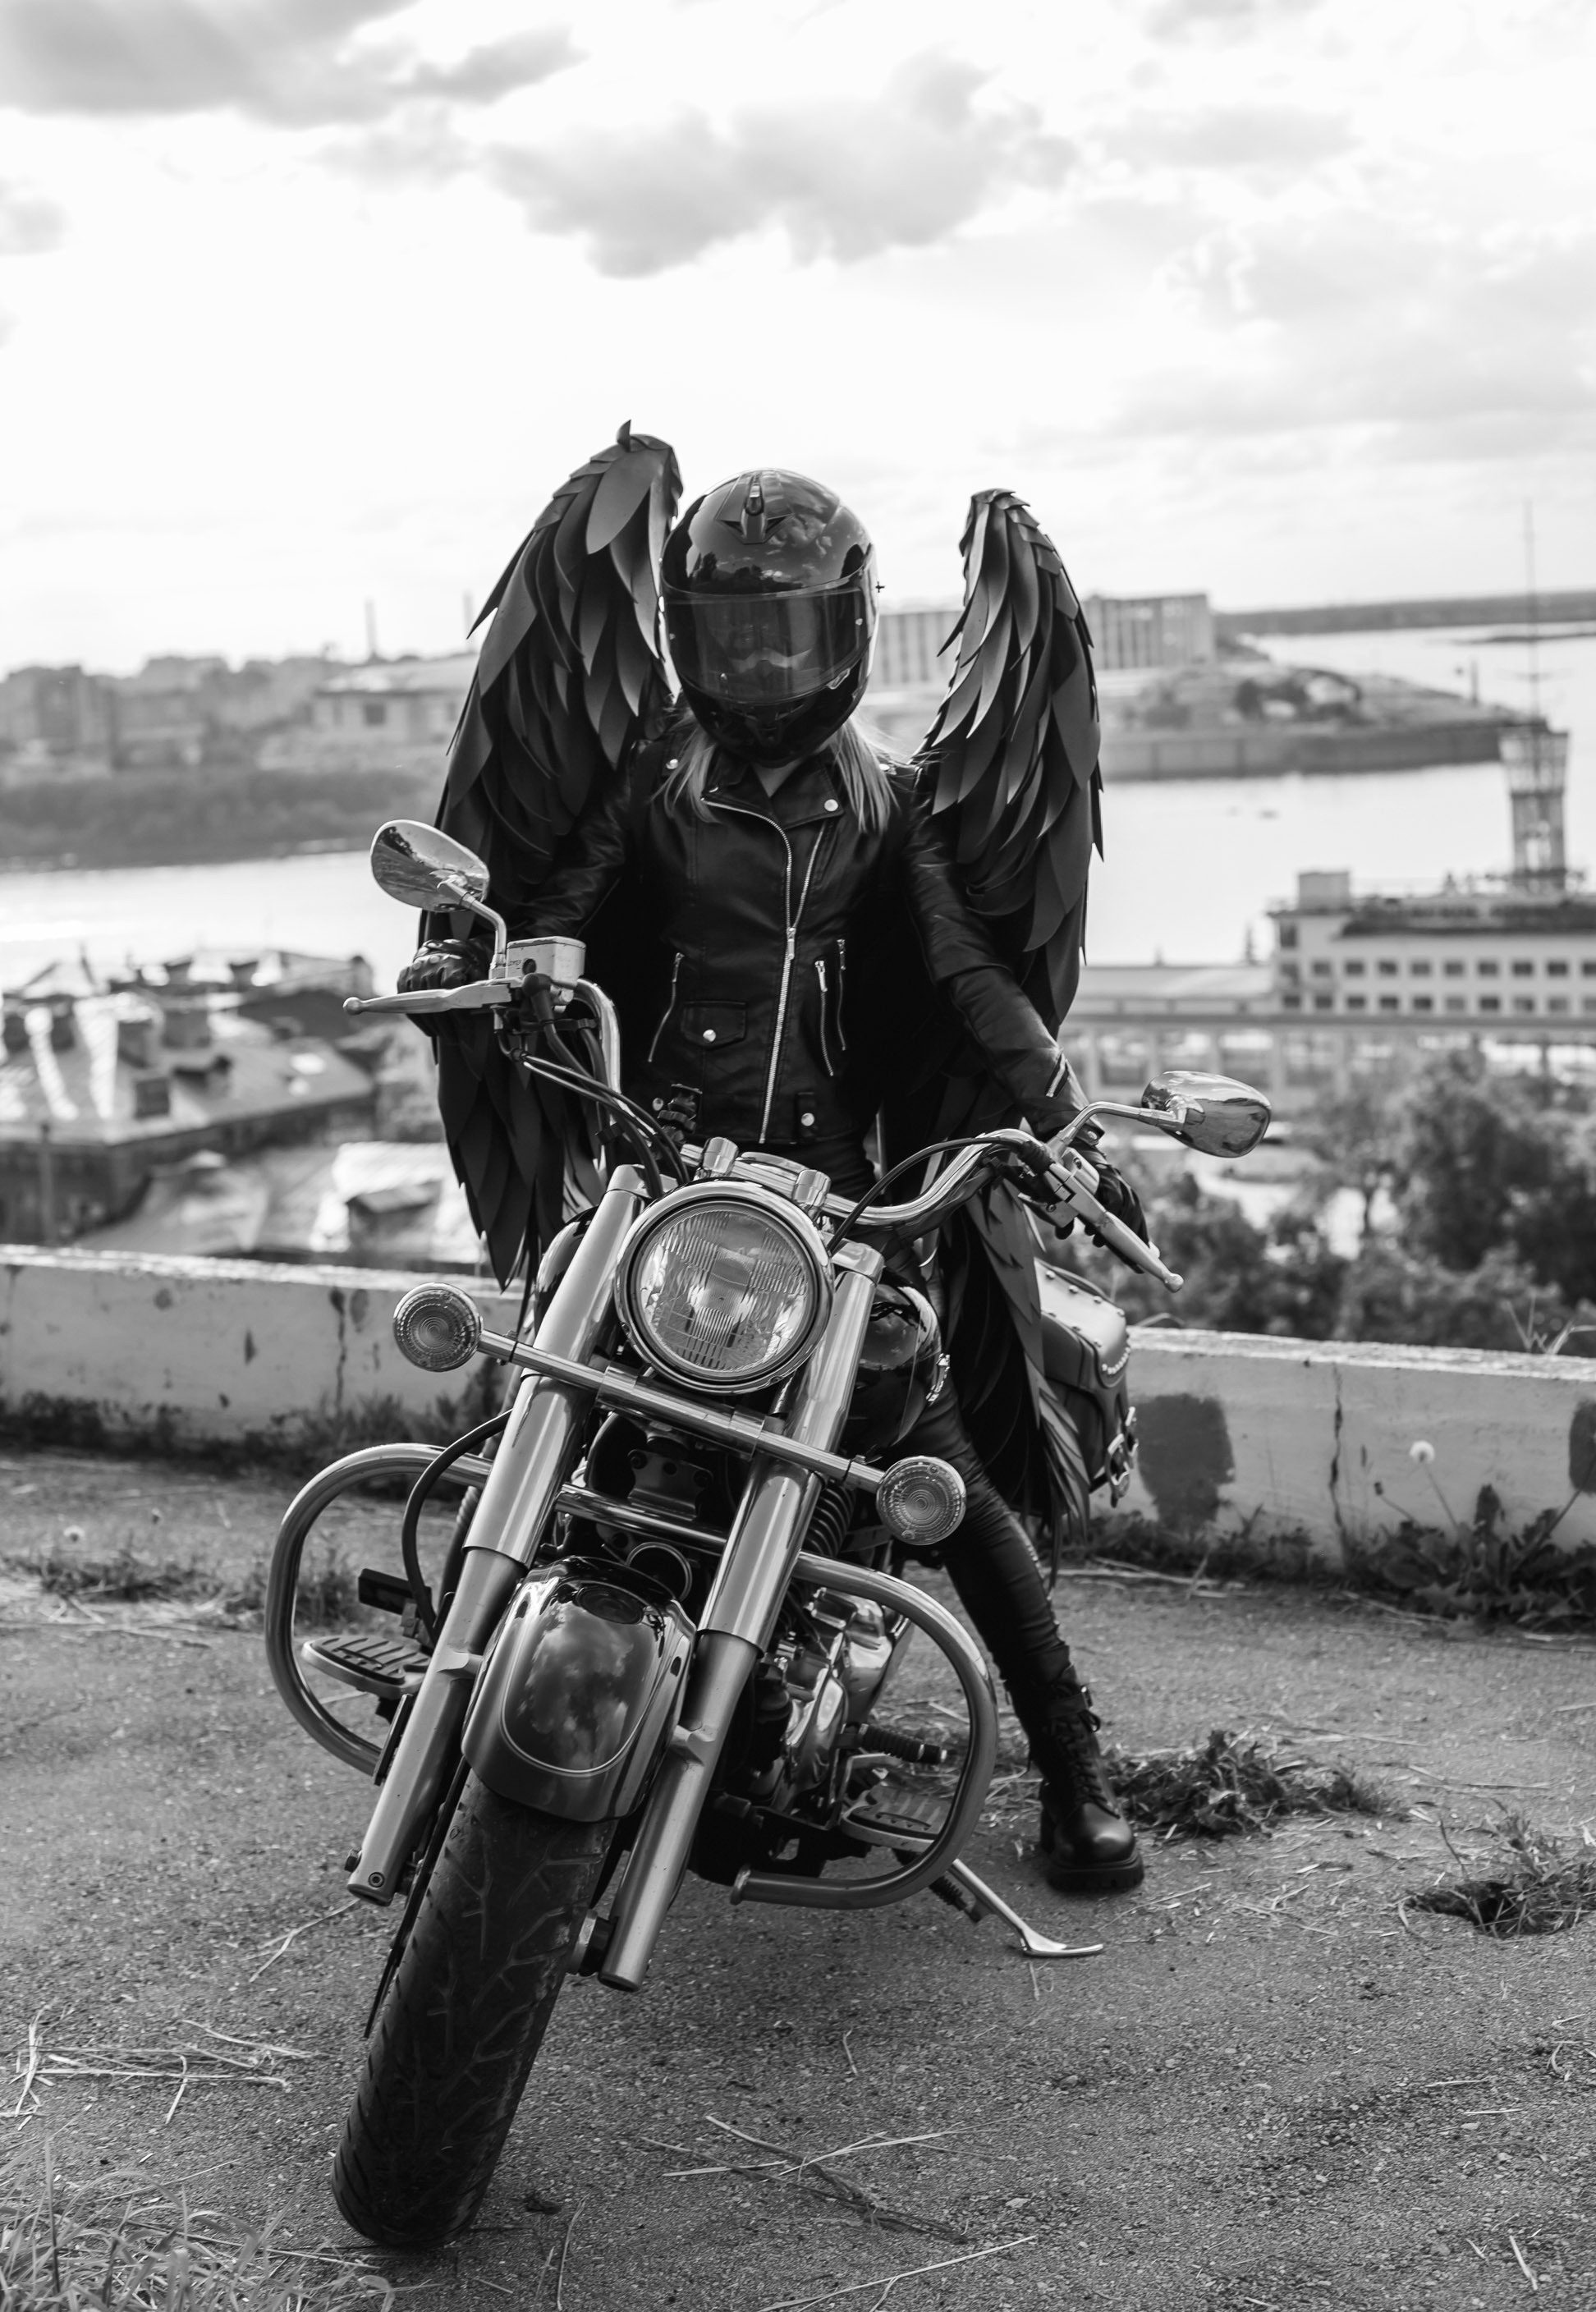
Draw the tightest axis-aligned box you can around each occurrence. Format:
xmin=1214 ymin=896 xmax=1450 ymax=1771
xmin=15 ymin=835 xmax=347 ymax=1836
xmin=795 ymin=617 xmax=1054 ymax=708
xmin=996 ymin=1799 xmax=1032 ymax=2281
xmin=659 ymin=467 xmax=877 ymax=763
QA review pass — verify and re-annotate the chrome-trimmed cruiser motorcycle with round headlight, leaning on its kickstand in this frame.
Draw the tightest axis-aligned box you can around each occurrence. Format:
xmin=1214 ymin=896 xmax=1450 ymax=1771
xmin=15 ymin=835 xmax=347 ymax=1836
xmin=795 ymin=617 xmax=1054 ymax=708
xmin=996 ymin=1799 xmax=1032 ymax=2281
xmin=266 ymin=821 xmax=1270 ymax=2247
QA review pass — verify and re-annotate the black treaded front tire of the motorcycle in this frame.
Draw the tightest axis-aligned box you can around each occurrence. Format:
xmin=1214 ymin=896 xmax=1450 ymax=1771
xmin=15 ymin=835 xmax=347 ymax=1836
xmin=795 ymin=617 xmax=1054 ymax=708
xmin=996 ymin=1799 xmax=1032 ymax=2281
xmin=333 ymin=1773 xmax=615 ymax=2247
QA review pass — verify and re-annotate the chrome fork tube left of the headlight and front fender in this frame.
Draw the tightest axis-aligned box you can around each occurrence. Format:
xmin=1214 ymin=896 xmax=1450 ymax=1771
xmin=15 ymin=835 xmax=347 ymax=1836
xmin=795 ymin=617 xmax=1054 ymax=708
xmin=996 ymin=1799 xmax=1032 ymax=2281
xmin=347 ymin=1165 xmax=643 ymax=1903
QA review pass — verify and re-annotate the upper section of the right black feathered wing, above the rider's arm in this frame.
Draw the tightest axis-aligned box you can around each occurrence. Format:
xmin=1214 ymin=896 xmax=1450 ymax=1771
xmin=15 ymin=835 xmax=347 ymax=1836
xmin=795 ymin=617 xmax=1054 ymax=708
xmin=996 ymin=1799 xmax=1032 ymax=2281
xmin=914 ymin=490 xmax=1103 ymax=1029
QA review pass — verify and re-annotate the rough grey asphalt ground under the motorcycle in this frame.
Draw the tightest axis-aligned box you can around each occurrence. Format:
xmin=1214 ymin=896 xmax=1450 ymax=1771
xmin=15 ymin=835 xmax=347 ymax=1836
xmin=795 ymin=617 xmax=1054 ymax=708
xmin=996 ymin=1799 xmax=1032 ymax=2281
xmin=0 ymin=1454 xmax=1596 ymax=2312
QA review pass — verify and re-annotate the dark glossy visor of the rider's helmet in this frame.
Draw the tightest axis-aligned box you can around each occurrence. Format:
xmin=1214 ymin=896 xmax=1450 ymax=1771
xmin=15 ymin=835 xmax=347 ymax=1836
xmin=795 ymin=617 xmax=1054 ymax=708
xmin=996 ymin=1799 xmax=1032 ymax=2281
xmin=664 ymin=585 xmax=877 ymax=708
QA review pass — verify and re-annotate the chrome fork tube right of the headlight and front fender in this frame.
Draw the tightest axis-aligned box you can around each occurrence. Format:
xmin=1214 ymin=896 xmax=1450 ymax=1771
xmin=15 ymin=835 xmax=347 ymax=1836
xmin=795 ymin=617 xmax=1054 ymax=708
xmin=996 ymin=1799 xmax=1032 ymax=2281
xmin=599 ymin=1244 xmax=883 ymax=1991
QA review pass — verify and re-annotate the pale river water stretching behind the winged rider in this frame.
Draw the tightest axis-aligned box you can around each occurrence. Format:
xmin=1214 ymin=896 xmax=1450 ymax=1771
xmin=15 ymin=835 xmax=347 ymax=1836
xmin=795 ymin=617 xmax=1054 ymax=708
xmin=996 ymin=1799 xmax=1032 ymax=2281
xmin=0 ymin=629 xmax=1596 ymax=987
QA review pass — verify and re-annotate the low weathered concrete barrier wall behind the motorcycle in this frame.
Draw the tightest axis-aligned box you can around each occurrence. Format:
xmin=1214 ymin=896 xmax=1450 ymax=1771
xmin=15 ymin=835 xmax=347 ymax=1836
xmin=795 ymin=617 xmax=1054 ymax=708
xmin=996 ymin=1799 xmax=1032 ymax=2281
xmin=0 ymin=1246 xmax=1596 ymax=1558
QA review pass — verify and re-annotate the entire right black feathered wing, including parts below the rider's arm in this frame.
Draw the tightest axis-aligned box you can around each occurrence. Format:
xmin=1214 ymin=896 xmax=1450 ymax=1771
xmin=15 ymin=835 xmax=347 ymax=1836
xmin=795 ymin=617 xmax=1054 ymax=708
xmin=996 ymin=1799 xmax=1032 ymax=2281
xmin=883 ymin=490 xmax=1103 ymax=1542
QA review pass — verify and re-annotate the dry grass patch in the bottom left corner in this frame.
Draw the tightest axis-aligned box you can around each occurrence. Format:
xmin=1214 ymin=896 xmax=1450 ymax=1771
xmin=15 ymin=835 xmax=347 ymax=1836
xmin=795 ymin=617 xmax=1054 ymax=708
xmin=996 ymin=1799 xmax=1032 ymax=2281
xmin=0 ymin=2136 xmax=396 ymax=2312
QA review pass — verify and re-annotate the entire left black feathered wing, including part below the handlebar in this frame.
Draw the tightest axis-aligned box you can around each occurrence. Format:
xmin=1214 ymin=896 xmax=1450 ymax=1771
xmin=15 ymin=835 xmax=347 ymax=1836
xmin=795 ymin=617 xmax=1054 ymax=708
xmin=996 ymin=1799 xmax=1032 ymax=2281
xmin=425 ymin=425 xmax=682 ymax=1283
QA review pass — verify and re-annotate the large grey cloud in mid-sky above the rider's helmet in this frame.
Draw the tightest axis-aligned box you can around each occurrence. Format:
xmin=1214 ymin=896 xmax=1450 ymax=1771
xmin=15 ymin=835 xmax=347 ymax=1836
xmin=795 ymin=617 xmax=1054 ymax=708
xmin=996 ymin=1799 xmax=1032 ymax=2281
xmin=476 ymin=56 xmax=1073 ymax=275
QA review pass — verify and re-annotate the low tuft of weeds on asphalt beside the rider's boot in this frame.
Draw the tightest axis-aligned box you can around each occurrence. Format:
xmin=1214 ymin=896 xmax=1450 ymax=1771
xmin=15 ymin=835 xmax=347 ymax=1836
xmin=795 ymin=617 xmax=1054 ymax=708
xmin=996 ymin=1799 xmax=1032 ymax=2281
xmin=1106 ymin=1727 xmax=1390 ymax=1838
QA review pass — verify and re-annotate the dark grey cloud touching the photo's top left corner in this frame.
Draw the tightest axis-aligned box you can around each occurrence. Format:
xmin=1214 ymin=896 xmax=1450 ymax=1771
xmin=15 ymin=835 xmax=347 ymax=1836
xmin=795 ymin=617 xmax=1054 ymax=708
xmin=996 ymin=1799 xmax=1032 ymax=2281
xmin=0 ymin=0 xmax=576 ymax=127
